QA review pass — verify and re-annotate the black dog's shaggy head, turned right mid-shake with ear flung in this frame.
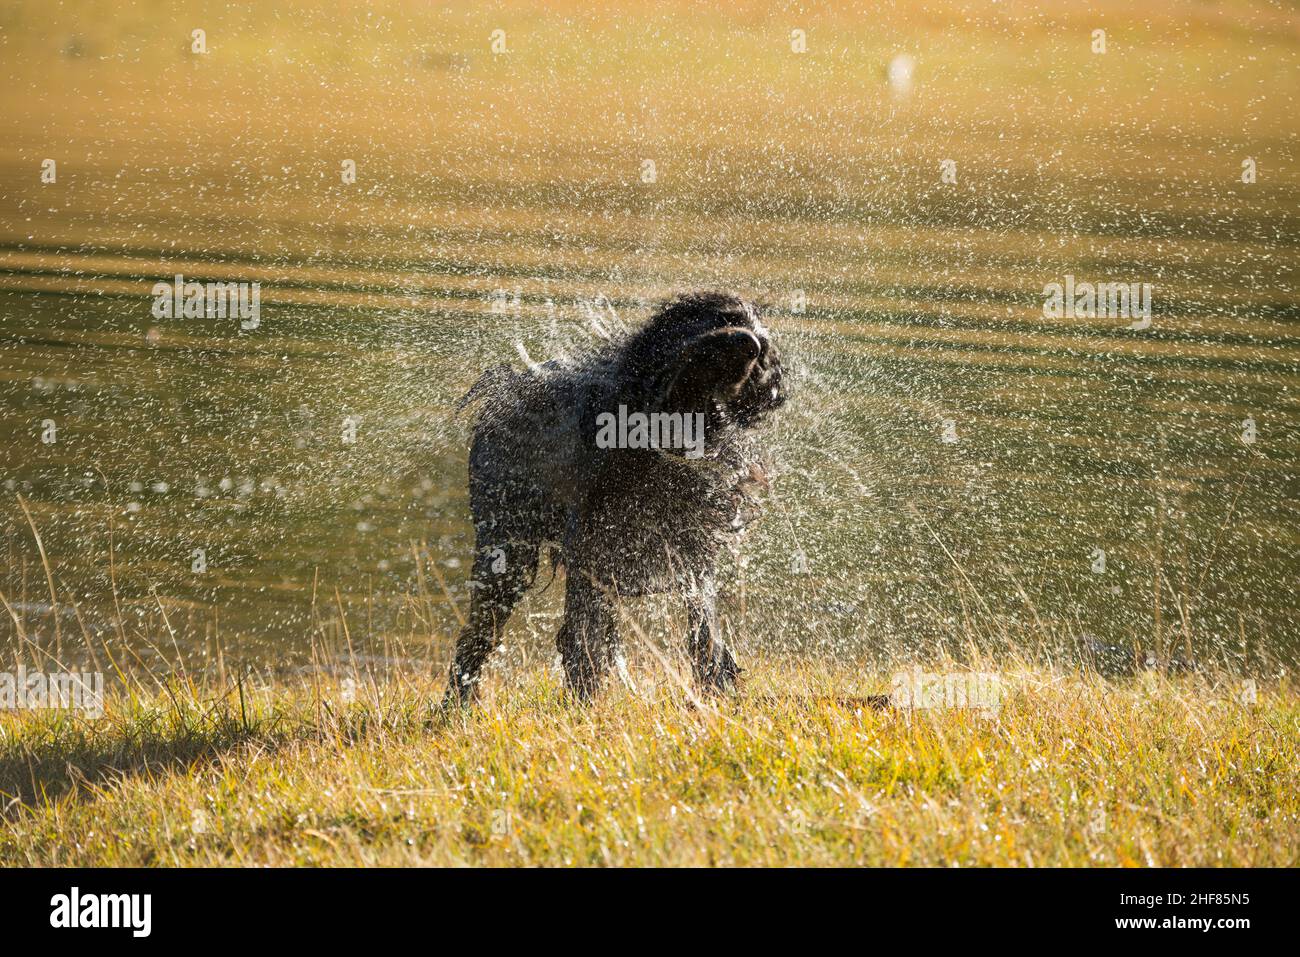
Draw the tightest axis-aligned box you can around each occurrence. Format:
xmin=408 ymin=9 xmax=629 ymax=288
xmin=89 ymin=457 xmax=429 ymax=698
xmin=623 ymin=293 xmax=787 ymax=428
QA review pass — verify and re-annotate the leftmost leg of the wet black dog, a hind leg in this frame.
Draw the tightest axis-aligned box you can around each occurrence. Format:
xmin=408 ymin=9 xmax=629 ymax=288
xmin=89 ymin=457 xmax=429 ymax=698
xmin=442 ymin=542 xmax=538 ymax=706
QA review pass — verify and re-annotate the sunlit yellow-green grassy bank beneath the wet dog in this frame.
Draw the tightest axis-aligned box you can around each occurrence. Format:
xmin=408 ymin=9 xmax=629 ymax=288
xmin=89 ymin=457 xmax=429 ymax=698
xmin=0 ymin=661 xmax=1300 ymax=866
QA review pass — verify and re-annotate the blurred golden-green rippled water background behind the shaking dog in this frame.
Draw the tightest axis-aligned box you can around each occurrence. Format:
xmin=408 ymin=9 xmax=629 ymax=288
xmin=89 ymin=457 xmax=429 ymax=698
xmin=0 ymin=0 xmax=1300 ymax=674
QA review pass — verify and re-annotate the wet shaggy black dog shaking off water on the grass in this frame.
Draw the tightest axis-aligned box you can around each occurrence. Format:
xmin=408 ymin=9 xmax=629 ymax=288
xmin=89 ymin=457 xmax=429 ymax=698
xmin=447 ymin=293 xmax=785 ymax=702
